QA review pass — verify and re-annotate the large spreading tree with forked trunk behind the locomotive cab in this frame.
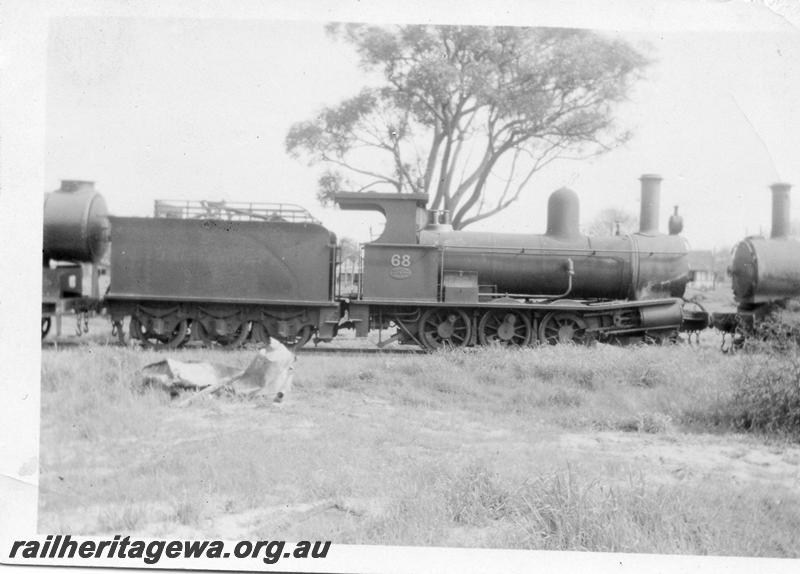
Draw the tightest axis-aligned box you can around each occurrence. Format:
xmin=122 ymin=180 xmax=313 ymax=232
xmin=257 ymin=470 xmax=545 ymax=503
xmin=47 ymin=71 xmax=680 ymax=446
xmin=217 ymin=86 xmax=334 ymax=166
xmin=286 ymin=24 xmax=648 ymax=229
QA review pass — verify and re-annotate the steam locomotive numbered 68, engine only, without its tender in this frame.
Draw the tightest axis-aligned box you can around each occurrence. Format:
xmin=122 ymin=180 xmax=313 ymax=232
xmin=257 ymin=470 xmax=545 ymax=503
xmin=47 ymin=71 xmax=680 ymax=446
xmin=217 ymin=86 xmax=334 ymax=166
xmin=336 ymin=175 xmax=688 ymax=348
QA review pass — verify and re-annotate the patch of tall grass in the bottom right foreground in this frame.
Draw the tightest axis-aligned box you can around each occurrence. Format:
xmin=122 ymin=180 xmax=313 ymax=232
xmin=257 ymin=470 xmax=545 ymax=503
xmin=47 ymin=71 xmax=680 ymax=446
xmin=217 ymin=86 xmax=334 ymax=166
xmin=358 ymin=461 xmax=800 ymax=557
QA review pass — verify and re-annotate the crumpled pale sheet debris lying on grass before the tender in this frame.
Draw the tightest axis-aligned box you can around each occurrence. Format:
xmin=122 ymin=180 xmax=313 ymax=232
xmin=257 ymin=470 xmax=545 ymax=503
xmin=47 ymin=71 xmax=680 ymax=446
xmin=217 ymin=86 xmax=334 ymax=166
xmin=141 ymin=339 xmax=296 ymax=406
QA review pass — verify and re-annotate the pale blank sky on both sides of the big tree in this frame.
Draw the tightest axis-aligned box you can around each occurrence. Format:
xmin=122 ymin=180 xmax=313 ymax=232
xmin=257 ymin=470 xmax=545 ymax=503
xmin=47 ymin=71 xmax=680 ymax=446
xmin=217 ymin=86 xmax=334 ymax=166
xmin=45 ymin=4 xmax=800 ymax=249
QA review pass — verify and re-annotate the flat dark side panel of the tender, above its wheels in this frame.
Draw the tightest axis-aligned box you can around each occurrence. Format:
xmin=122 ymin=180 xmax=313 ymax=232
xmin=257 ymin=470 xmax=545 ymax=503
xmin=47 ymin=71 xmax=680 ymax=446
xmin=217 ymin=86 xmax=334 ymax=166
xmin=108 ymin=217 xmax=333 ymax=302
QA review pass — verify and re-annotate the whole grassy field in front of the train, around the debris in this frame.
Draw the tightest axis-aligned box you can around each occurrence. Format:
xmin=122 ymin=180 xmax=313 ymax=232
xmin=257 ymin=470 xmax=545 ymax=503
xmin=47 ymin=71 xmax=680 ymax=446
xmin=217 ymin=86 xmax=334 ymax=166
xmin=40 ymin=344 xmax=800 ymax=557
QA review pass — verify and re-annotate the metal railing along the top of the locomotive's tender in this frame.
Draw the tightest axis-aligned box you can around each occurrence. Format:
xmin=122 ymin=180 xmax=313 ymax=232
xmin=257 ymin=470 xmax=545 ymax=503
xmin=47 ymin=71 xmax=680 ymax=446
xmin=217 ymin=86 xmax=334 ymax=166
xmin=153 ymin=199 xmax=319 ymax=223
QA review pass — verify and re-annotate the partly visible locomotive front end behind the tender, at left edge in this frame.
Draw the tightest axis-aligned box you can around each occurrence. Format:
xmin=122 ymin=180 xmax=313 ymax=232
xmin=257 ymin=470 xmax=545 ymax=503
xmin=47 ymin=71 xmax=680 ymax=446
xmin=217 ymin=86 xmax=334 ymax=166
xmin=42 ymin=180 xmax=109 ymax=338
